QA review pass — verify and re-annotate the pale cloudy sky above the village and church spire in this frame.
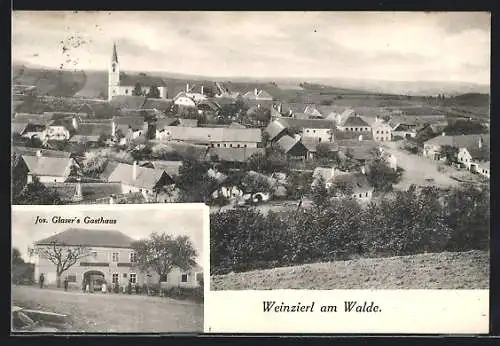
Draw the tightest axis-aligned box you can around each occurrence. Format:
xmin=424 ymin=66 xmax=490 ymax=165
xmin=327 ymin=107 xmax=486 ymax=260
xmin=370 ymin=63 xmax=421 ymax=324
xmin=12 ymin=11 xmax=490 ymax=85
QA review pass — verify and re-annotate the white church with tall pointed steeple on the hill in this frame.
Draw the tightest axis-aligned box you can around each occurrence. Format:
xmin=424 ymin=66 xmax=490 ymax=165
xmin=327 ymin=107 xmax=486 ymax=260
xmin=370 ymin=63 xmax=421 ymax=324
xmin=108 ymin=43 xmax=168 ymax=101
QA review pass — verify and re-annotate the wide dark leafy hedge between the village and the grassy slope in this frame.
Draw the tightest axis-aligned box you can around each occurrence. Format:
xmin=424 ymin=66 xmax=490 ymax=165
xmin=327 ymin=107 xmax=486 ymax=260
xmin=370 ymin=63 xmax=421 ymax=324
xmin=210 ymin=186 xmax=490 ymax=275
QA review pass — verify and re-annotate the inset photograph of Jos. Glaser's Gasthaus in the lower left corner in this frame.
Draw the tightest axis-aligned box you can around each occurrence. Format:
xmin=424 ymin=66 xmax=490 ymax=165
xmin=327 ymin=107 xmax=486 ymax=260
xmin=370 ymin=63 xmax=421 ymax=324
xmin=11 ymin=204 xmax=208 ymax=334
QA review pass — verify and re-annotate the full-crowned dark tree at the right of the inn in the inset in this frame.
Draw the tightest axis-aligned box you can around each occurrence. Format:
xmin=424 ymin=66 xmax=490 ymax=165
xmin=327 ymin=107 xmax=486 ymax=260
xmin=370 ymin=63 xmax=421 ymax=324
xmin=132 ymin=233 xmax=197 ymax=294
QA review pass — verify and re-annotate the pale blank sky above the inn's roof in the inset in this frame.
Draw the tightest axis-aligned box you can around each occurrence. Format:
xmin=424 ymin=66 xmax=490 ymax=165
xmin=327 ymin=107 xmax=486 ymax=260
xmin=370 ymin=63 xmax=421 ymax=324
xmin=12 ymin=204 xmax=208 ymax=266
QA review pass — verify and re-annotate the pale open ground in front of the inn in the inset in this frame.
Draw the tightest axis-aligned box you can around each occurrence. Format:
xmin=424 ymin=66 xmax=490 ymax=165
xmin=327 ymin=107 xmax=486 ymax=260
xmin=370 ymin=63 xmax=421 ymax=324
xmin=12 ymin=286 xmax=203 ymax=333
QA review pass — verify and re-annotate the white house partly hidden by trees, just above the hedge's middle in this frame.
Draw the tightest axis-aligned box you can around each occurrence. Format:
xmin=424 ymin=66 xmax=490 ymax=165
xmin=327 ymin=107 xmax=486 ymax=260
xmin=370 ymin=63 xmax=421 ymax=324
xmin=312 ymin=167 xmax=374 ymax=202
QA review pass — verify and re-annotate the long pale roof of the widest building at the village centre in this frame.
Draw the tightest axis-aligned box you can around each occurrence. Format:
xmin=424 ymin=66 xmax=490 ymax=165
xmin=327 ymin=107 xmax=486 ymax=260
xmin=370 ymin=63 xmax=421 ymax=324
xmin=161 ymin=126 xmax=262 ymax=143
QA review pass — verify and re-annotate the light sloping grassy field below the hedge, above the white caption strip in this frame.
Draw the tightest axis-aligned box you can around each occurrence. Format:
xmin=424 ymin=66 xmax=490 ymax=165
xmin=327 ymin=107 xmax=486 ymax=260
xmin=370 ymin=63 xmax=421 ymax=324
xmin=210 ymin=251 xmax=489 ymax=290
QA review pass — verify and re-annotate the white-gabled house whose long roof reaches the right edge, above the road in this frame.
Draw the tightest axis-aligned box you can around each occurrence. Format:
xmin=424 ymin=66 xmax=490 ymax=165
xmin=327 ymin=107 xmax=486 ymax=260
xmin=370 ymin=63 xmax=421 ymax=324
xmin=422 ymin=132 xmax=489 ymax=160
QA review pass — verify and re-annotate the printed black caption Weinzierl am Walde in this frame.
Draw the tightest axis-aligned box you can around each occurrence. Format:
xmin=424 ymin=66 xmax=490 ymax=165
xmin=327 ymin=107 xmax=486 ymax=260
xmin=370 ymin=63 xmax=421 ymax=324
xmin=263 ymin=300 xmax=382 ymax=313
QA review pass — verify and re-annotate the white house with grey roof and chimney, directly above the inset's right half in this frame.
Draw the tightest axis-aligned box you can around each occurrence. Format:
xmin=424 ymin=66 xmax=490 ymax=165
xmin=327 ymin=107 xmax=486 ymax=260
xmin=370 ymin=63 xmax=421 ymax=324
xmin=101 ymin=161 xmax=174 ymax=197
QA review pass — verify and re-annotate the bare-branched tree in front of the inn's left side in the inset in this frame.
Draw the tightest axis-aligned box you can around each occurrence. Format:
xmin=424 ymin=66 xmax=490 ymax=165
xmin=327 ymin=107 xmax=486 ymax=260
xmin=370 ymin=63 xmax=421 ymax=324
xmin=34 ymin=241 xmax=90 ymax=288
